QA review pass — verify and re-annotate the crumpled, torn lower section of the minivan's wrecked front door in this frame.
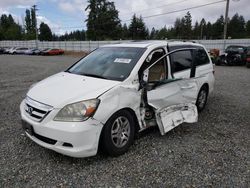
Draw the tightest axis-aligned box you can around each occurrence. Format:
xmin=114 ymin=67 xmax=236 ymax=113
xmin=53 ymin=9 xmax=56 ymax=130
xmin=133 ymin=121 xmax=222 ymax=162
xmin=156 ymin=103 xmax=198 ymax=135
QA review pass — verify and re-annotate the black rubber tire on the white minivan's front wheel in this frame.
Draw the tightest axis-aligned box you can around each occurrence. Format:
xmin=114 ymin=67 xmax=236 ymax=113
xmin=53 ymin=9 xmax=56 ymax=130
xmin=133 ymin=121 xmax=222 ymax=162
xmin=100 ymin=110 xmax=135 ymax=156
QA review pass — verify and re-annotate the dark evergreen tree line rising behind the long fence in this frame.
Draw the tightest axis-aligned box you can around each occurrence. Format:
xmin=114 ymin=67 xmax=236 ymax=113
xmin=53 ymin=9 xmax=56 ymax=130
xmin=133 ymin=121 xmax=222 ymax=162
xmin=0 ymin=0 xmax=250 ymax=41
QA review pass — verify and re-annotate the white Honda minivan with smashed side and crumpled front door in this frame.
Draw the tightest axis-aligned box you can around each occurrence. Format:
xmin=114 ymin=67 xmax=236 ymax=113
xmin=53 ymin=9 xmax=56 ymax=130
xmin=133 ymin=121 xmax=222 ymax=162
xmin=20 ymin=41 xmax=214 ymax=157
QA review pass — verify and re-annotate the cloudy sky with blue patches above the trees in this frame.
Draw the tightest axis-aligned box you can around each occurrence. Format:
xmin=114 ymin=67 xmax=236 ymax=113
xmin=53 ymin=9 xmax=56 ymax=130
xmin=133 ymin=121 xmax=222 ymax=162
xmin=0 ymin=0 xmax=250 ymax=34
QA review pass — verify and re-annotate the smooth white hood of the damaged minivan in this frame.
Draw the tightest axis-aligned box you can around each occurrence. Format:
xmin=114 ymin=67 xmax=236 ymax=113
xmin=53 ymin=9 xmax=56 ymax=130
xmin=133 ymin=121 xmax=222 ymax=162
xmin=27 ymin=72 xmax=120 ymax=108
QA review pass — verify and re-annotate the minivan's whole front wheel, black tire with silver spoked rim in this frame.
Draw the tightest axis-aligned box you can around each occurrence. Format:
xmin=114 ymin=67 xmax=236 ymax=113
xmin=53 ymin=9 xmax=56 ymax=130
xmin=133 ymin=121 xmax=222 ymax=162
xmin=100 ymin=110 xmax=135 ymax=156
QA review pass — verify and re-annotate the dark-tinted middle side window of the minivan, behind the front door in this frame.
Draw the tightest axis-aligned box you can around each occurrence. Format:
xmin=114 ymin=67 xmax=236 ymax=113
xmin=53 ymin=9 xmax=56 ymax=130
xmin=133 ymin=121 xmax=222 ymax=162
xmin=170 ymin=50 xmax=192 ymax=73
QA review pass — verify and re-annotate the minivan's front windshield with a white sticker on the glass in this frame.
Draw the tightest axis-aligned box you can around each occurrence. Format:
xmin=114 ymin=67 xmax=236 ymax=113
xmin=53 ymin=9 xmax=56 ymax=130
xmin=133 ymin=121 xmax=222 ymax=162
xmin=67 ymin=47 xmax=146 ymax=81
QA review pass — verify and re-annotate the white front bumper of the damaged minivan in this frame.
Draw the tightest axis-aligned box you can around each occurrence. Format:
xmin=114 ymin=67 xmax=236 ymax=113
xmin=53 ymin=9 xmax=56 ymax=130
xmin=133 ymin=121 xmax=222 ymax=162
xmin=20 ymin=101 xmax=103 ymax=157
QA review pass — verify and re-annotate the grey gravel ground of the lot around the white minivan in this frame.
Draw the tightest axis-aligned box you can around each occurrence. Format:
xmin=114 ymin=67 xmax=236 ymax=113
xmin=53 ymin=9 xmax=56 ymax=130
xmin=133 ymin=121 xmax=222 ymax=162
xmin=0 ymin=55 xmax=250 ymax=187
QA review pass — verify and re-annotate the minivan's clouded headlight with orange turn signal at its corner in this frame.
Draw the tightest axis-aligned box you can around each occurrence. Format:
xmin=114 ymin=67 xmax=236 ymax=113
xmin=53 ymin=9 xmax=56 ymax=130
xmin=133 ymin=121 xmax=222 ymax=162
xmin=54 ymin=99 xmax=100 ymax=122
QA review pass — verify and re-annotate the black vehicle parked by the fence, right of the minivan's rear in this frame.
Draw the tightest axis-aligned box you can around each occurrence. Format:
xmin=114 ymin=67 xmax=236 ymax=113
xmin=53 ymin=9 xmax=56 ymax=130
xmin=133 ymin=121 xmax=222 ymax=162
xmin=215 ymin=45 xmax=247 ymax=65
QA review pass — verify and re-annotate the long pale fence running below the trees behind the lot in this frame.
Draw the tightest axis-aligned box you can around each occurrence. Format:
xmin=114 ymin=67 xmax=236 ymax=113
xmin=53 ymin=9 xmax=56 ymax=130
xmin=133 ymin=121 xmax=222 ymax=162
xmin=0 ymin=39 xmax=250 ymax=51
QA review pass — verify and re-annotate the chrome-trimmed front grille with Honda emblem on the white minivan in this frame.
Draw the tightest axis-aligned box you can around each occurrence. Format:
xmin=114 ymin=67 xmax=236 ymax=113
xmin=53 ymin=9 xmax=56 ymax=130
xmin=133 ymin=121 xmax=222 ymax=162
xmin=24 ymin=97 xmax=53 ymax=122
